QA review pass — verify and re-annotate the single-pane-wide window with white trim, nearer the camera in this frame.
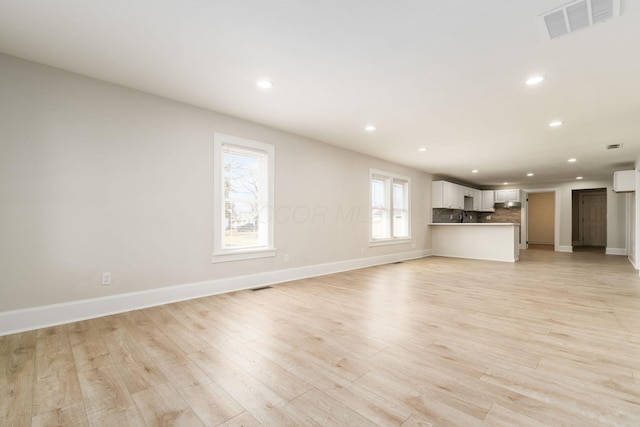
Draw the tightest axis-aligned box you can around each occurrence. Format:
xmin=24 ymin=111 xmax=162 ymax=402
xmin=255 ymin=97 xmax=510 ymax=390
xmin=212 ymin=133 xmax=275 ymax=262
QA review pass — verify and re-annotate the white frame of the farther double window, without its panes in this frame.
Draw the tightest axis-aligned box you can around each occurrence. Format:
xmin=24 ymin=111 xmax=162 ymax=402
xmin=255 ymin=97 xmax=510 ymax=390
xmin=368 ymin=169 xmax=411 ymax=246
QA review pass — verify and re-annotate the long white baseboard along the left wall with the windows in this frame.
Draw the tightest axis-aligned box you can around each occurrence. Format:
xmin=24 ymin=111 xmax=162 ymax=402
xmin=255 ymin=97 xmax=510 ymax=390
xmin=0 ymin=249 xmax=431 ymax=336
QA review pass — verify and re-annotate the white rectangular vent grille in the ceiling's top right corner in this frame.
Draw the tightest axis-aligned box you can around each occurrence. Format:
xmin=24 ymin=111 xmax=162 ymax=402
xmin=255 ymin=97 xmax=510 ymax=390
xmin=541 ymin=0 xmax=622 ymax=40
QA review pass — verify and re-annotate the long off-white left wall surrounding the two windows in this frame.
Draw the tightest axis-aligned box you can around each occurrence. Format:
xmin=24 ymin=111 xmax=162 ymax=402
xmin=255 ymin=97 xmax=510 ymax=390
xmin=0 ymin=51 xmax=431 ymax=312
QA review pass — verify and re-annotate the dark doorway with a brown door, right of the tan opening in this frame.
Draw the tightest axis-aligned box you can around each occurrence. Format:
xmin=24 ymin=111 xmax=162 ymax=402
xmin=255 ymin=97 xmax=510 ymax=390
xmin=571 ymin=188 xmax=607 ymax=253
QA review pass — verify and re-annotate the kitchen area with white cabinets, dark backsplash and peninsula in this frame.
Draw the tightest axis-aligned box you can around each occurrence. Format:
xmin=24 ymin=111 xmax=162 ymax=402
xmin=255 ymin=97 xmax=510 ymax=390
xmin=429 ymin=181 xmax=525 ymax=262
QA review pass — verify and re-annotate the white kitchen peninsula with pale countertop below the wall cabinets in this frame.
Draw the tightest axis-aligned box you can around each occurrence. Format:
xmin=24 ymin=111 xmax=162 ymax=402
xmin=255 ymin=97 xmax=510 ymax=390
xmin=429 ymin=223 xmax=520 ymax=262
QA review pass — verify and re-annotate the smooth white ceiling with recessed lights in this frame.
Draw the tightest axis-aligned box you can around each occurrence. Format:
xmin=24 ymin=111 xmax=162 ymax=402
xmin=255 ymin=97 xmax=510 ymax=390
xmin=0 ymin=0 xmax=640 ymax=186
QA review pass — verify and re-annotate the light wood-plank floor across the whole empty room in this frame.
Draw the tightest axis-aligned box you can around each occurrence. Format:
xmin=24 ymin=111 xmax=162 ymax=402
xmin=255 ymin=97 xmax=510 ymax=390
xmin=0 ymin=250 xmax=640 ymax=427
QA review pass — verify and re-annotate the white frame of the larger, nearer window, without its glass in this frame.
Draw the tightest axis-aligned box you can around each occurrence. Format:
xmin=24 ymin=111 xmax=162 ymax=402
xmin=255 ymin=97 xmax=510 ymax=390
xmin=211 ymin=133 xmax=276 ymax=263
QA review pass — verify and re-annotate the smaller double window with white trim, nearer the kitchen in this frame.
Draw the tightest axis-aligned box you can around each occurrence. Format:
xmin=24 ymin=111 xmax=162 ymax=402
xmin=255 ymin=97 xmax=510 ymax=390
xmin=369 ymin=169 xmax=411 ymax=243
